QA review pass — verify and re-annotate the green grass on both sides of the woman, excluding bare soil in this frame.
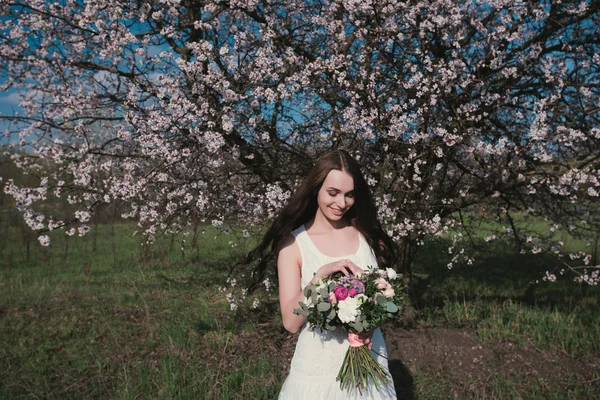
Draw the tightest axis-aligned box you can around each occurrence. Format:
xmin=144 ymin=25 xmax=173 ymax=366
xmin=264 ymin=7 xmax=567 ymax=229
xmin=0 ymin=220 xmax=600 ymax=399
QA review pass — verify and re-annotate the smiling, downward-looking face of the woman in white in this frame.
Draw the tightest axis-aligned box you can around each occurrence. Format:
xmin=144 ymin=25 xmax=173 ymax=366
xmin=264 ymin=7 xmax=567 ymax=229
xmin=317 ymin=169 xmax=354 ymax=221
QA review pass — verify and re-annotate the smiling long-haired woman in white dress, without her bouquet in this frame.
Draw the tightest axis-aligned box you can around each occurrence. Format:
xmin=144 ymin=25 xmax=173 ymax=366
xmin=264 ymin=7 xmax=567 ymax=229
xmin=248 ymin=150 xmax=396 ymax=400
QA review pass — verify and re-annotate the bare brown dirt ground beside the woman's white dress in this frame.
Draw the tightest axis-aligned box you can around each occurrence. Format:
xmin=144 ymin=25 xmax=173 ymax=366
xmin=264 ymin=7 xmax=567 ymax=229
xmin=272 ymin=325 xmax=600 ymax=399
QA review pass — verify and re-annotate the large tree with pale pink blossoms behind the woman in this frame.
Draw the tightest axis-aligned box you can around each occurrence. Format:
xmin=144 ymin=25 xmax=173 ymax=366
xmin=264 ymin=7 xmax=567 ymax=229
xmin=0 ymin=0 xmax=600 ymax=284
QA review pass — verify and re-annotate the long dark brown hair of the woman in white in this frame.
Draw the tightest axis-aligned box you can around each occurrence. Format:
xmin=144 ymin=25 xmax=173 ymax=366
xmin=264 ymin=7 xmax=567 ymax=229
xmin=245 ymin=150 xmax=396 ymax=282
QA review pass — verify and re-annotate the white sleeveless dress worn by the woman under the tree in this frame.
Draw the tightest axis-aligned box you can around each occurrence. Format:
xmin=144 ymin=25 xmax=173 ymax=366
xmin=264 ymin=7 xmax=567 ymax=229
xmin=279 ymin=225 xmax=396 ymax=400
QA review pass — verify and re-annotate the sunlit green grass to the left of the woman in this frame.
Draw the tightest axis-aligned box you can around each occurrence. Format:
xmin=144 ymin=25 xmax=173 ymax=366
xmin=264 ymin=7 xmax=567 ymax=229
xmin=0 ymin=224 xmax=283 ymax=399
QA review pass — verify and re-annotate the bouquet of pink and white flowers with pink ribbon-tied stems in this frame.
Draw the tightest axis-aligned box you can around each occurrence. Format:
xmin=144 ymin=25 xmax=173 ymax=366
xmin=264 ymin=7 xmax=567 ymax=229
xmin=294 ymin=268 xmax=408 ymax=392
